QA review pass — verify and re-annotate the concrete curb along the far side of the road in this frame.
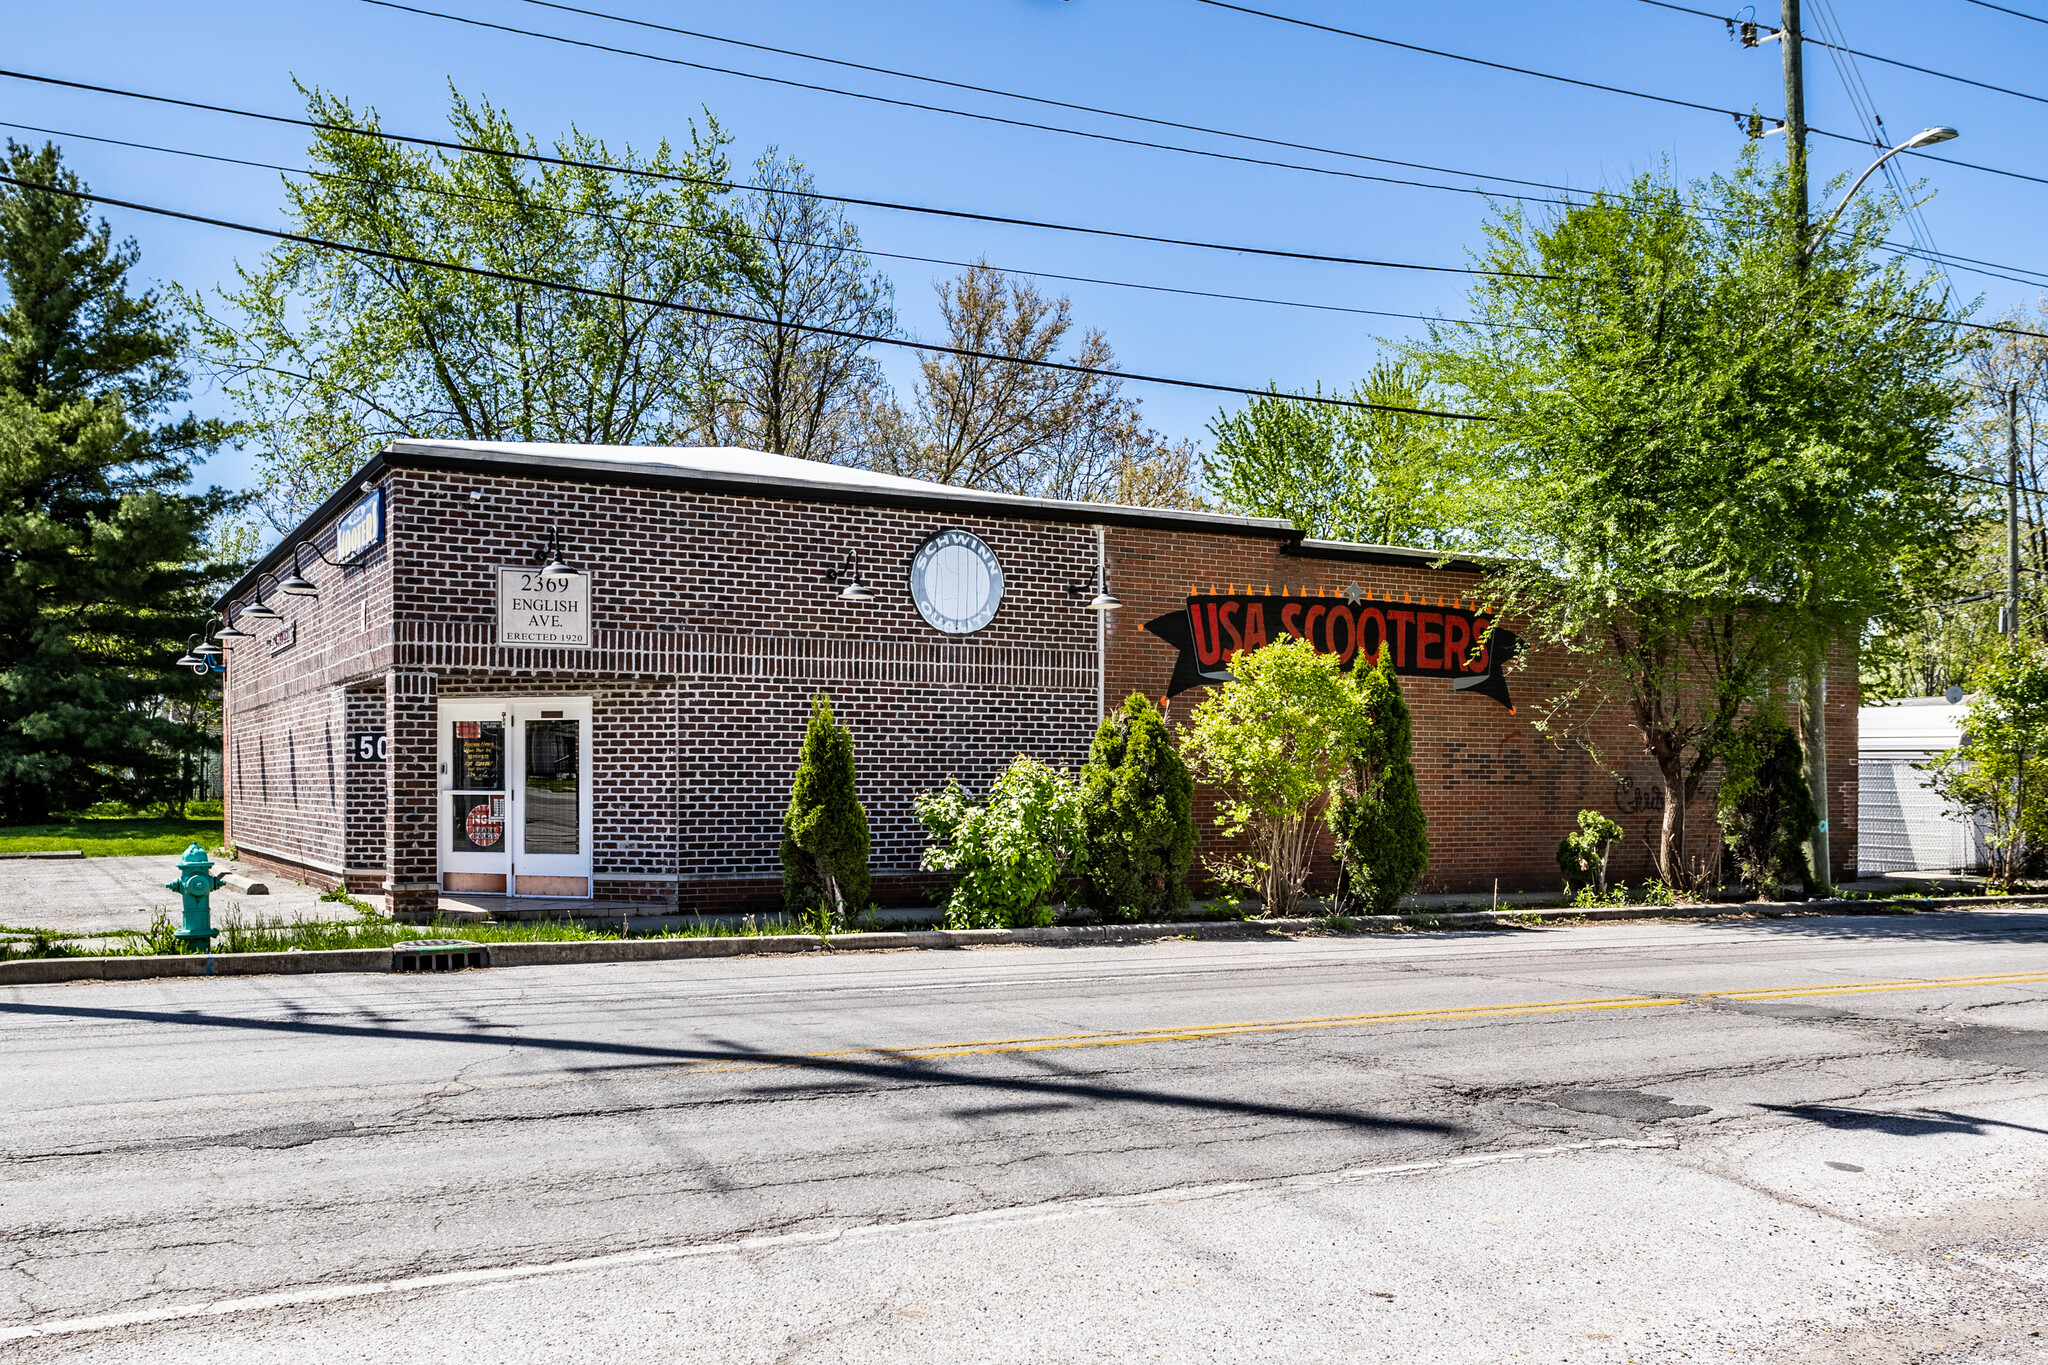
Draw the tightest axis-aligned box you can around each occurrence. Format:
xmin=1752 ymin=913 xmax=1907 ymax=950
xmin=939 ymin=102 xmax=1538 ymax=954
xmin=0 ymin=894 xmax=2048 ymax=986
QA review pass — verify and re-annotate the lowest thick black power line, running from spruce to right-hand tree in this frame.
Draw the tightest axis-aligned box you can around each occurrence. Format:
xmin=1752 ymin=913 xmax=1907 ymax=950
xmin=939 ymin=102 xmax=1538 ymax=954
xmin=0 ymin=176 xmax=1493 ymax=422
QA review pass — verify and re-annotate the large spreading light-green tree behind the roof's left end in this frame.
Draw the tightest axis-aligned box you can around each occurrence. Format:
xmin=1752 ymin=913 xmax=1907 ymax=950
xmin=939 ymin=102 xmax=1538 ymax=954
xmin=184 ymin=90 xmax=758 ymax=528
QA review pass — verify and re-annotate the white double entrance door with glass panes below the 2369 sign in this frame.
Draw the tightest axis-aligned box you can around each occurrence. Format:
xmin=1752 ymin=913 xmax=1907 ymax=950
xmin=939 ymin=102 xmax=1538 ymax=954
xmin=440 ymin=698 xmax=592 ymax=898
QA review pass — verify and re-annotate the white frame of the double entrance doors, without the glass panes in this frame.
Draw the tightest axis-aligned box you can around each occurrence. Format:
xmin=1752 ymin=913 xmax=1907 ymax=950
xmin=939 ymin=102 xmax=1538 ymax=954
xmin=434 ymin=698 xmax=596 ymax=898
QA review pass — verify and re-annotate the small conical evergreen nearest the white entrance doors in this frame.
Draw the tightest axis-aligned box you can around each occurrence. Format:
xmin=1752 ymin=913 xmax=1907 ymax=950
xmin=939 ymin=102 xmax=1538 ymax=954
xmin=782 ymin=694 xmax=872 ymax=927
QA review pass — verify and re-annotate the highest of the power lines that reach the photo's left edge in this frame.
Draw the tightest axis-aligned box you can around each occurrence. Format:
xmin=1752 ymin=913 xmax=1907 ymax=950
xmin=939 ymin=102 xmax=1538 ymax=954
xmin=0 ymin=70 xmax=1552 ymax=280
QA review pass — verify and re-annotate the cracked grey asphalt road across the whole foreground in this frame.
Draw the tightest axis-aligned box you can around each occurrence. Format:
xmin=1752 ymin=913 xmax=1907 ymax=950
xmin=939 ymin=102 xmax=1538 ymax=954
xmin=0 ymin=911 xmax=2048 ymax=1363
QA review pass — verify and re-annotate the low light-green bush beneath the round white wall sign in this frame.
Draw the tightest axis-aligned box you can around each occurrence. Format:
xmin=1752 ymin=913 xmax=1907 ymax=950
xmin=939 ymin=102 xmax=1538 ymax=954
xmin=913 ymin=753 xmax=1081 ymax=929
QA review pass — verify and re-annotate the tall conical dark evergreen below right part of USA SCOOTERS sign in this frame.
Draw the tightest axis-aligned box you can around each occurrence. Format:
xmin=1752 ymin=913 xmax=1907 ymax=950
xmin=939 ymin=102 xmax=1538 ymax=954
xmin=1329 ymin=649 xmax=1430 ymax=915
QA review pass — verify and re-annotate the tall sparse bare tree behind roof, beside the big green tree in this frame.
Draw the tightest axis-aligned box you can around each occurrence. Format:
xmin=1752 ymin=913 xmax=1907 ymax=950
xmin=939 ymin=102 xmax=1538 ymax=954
xmin=702 ymin=147 xmax=895 ymax=465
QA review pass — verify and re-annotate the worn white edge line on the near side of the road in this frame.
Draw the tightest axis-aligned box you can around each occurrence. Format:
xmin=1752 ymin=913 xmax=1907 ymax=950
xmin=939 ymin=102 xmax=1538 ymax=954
xmin=0 ymin=1138 xmax=1677 ymax=1345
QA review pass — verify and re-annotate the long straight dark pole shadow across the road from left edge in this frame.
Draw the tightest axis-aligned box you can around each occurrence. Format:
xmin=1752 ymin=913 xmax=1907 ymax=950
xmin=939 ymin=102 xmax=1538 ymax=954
xmin=0 ymin=1003 xmax=1464 ymax=1136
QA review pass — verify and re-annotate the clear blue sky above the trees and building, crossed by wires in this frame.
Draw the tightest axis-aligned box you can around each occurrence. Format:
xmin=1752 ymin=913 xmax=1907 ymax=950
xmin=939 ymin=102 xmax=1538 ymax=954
xmin=0 ymin=0 xmax=2048 ymax=499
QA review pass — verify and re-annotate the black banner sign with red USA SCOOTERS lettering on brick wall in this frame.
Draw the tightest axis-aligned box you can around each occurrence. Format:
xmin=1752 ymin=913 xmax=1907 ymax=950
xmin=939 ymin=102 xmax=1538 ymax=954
xmin=1145 ymin=593 xmax=1522 ymax=714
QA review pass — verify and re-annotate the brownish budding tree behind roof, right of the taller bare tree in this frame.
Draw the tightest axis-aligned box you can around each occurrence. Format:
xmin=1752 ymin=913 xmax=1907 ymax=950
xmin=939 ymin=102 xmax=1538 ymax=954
xmin=866 ymin=262 xmax=1200 ymax=508
